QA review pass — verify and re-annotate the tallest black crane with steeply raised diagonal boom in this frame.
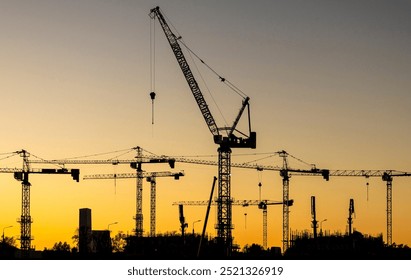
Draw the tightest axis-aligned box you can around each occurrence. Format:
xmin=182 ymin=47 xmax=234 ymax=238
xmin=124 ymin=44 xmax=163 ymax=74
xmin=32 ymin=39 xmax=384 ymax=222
xmin=150 ymin=7 xmax=256 ymax=256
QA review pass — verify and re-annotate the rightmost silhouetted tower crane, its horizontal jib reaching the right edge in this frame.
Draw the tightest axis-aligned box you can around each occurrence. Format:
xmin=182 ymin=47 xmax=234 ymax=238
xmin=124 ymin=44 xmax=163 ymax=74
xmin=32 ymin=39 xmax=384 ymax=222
xmin=298 ymin=170 xmax=411 ymax=246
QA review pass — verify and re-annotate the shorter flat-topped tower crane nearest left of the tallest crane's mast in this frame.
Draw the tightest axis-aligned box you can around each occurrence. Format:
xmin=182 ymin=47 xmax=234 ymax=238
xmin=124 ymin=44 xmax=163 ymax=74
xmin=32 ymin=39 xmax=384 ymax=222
xmin=83 ymin=171 xmax=184 ymax=237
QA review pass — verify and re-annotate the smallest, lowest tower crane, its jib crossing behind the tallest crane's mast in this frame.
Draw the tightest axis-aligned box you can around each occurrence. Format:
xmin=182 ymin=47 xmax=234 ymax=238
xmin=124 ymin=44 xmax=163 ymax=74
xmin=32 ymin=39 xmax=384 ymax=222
xmin=172 ymin=199 xmax=294 ymax=249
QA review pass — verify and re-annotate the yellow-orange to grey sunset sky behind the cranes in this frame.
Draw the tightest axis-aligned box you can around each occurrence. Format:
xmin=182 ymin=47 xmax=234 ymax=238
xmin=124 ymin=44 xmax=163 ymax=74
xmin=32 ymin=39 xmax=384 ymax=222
xmin=0 ymin=0 xmax=411 ymax=249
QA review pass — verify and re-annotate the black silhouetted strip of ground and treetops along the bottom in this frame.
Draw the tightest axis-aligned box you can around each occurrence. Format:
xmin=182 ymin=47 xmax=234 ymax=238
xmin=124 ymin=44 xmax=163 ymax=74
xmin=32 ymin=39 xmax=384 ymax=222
xmin=0 ymin=232 xmax=411 ymax=260
